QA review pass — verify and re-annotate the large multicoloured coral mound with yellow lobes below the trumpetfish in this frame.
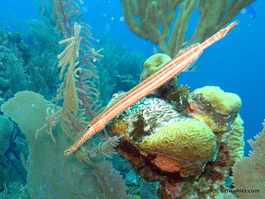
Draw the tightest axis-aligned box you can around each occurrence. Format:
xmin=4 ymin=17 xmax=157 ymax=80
xmin=107 ymin=84 xmax=244 ymax=198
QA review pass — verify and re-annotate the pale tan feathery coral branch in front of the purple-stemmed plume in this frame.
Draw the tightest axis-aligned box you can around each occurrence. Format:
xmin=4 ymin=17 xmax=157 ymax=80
xmin=36 ymin=24 xmax=81 ymax=142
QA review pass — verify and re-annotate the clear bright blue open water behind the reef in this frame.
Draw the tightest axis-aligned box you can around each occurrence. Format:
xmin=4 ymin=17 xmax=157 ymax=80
xmin=0 ymin=0 xmax=265 ymax=155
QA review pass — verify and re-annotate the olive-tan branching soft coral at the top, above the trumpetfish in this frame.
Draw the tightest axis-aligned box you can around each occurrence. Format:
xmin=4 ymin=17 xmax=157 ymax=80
xmin=122 ymin=0 xmax=255 ymax=57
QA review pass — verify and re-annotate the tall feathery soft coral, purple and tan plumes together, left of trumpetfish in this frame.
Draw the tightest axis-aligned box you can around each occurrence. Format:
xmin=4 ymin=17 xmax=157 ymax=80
xmin=34 ymin=0 xmax=115 ymax=164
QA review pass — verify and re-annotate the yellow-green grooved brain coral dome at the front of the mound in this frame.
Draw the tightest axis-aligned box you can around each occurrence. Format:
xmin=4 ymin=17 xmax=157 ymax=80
xmin=140 ymin=119 xmax=217 ymax=163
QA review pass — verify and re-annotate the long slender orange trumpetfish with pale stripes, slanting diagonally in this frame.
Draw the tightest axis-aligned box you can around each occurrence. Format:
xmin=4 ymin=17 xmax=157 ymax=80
xmin=64 ymin=21 xmax=238 ymax=155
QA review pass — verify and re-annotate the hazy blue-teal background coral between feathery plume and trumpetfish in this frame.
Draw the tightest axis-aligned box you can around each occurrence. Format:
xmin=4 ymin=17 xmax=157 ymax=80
xmin=94 ymin=35 xmax=146 ymax=106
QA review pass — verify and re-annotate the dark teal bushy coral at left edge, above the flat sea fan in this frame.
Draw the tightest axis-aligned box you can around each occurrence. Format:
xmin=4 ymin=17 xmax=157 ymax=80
xmin=0 ymin=31 xmax=30 ymax=101
